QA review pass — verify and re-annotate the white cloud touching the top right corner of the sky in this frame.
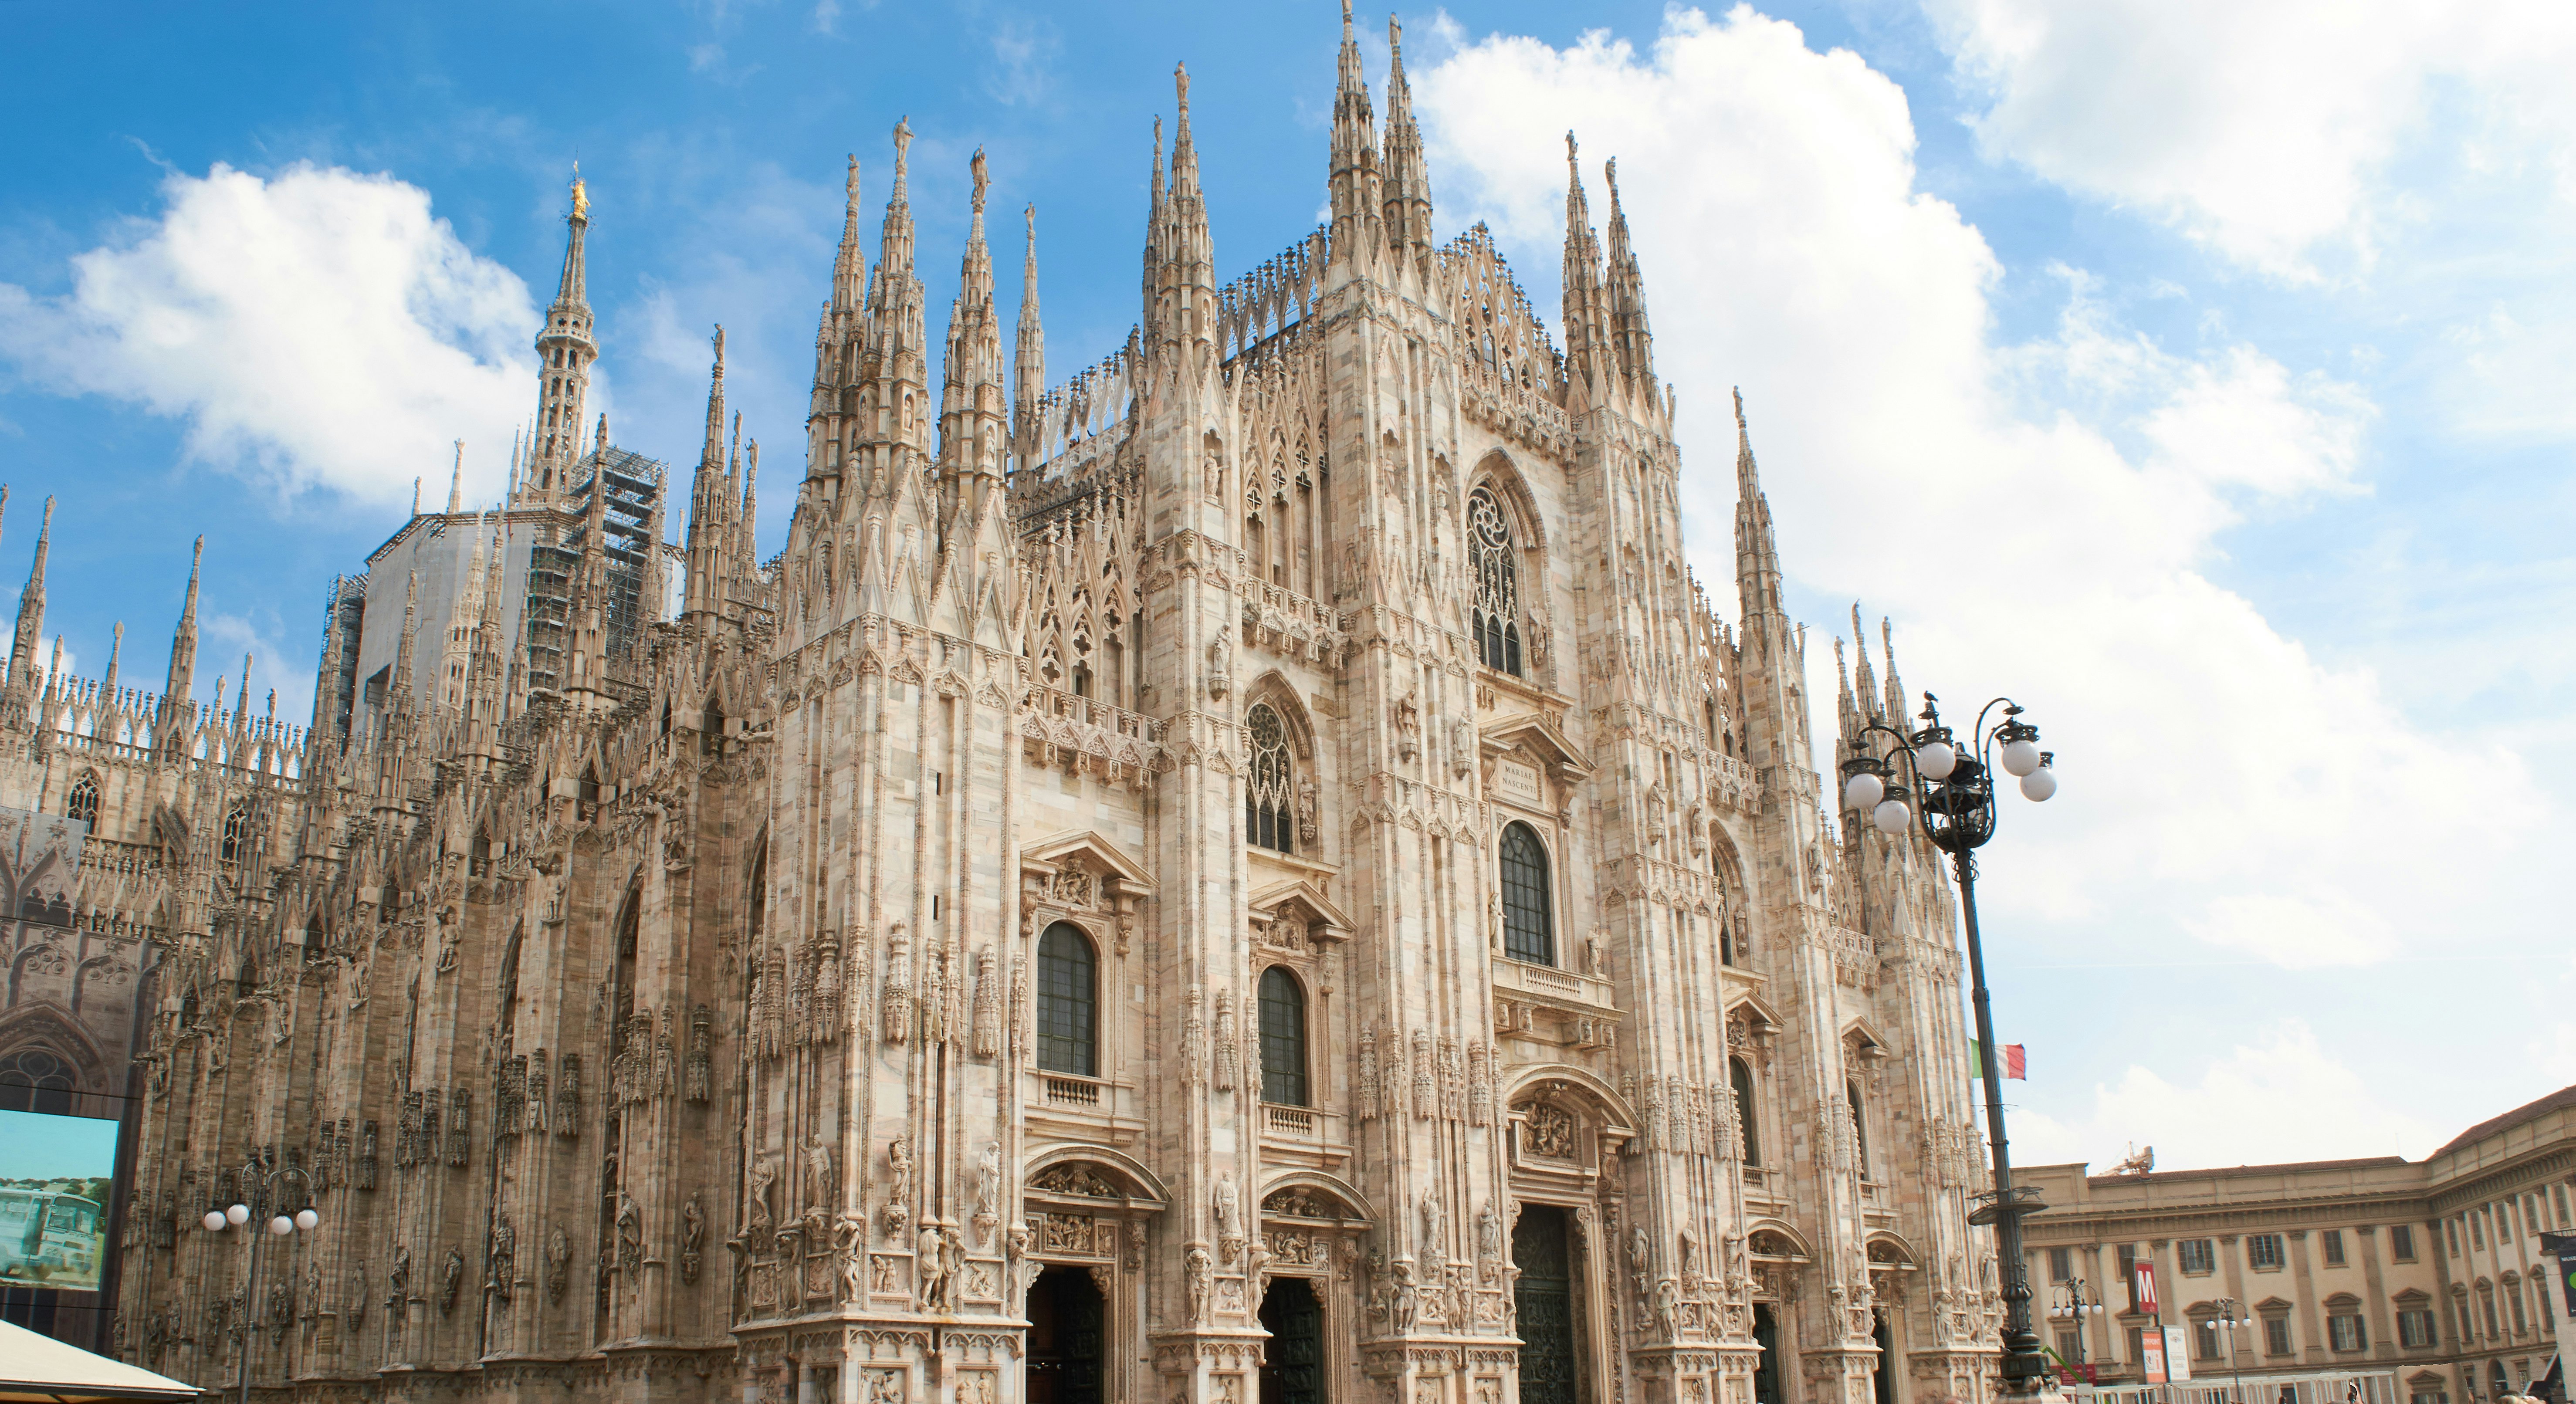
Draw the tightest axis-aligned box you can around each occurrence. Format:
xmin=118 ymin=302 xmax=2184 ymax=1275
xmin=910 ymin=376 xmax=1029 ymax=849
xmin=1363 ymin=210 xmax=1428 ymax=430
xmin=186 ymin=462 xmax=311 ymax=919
xmin=1924 ymin=0 xmax=2576 ymax=276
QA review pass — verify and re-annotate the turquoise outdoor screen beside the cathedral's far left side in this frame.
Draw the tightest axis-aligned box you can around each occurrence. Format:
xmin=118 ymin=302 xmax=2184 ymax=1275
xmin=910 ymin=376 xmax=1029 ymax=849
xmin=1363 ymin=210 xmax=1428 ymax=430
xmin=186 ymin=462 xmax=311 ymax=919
xmin=0 ymin=1110 xmax=116 ymax=1291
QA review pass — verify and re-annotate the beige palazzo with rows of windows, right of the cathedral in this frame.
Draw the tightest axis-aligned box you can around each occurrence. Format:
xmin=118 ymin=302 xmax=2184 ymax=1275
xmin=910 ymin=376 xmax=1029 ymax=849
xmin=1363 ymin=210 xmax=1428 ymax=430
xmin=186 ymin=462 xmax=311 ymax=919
xmin=2014 ymin=1087 xmax=2576 ymax=1404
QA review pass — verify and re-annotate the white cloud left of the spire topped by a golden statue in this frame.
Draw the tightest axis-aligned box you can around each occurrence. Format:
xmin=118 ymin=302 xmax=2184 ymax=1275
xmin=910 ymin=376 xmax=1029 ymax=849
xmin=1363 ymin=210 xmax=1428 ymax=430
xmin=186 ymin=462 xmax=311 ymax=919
xmin=0 ymin=165 xmax=538 ymax=505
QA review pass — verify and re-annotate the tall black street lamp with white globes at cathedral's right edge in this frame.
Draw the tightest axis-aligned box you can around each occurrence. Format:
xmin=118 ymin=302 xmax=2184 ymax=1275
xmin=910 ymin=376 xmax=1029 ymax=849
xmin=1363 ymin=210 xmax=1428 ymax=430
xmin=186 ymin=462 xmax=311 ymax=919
xmin=1842 ymin=693 xmax=2058 ymax=1394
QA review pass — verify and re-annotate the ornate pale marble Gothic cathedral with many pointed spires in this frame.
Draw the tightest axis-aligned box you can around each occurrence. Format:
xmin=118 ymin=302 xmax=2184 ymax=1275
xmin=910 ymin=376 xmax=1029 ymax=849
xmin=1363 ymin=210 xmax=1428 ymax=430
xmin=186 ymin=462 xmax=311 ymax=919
xmin=91 ymin=20 xmax=2001 ymax=1404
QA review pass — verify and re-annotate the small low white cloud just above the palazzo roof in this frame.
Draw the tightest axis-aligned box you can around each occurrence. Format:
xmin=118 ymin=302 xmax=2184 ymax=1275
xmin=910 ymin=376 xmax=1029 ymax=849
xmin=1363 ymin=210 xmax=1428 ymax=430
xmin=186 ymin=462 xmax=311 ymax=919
xmin=2004 ymin=1020 xmax=2468 ymax=1159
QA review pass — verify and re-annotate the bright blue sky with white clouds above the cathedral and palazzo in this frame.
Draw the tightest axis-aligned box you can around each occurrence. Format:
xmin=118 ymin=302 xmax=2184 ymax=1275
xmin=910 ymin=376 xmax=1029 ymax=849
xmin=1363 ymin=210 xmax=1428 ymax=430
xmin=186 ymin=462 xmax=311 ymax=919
xmin=0 ymin=0 xmax=2576 ymax=1164
